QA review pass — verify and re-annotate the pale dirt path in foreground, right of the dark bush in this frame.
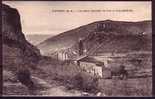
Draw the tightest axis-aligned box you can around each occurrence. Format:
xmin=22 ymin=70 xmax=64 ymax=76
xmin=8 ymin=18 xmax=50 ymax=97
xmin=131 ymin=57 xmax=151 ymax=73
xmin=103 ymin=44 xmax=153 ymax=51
xmin=28 ymin=77 xmax=82 ymax=96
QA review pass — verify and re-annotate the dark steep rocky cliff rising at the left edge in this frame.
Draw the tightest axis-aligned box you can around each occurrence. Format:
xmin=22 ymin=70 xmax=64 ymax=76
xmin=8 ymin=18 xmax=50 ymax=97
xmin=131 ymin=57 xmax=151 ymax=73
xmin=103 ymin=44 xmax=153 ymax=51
xmin=2 ymin=4 xmax=40 ymax=71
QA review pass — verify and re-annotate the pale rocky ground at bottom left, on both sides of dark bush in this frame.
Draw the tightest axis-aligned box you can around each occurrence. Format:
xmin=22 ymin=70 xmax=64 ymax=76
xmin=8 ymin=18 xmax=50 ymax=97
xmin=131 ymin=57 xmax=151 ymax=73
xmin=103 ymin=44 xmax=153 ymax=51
xmin=3 ymin=71 xmax=81 ymax=96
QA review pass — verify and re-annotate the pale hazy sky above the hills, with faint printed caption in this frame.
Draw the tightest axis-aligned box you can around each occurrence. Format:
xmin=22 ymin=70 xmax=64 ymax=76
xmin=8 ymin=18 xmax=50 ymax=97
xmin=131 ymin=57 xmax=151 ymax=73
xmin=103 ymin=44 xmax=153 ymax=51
xmin=3 ymin=1 xmax=152 ymax=35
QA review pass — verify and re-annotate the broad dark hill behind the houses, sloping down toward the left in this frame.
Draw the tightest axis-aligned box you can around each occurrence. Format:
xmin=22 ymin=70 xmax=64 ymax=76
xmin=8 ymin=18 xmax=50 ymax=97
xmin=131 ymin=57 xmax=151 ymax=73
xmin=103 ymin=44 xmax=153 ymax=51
xmin=37 ymin=20 xmax=152 ymax=55
